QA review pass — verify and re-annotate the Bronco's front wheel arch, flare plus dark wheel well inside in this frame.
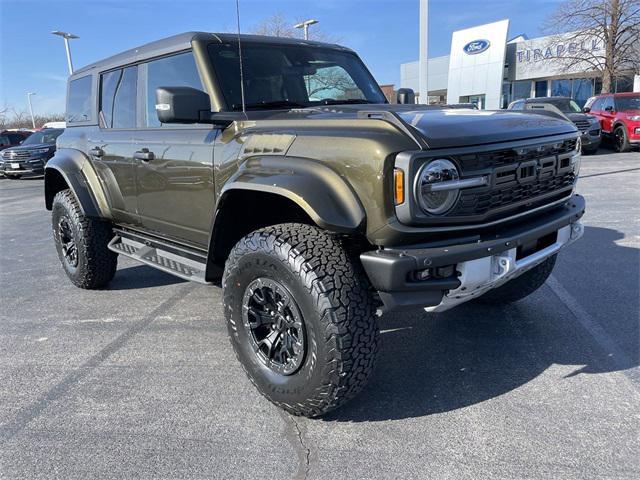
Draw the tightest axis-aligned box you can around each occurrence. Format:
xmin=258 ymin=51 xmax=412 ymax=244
xmin=202 ymin=156 xmax=365 ymax=279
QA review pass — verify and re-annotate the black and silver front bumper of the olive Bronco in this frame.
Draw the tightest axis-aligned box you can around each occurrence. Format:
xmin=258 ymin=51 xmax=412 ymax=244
xmin=360 ymin=195 xmax=585 ymax=311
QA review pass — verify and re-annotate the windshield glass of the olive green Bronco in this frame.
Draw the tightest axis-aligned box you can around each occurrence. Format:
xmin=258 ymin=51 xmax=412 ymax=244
xmin=209 ymin=42 xmax=386 ymax=110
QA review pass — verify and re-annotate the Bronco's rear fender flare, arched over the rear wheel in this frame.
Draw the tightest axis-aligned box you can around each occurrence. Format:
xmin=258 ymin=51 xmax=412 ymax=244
xmin=44 ymin=148 xmax=112 ymax=219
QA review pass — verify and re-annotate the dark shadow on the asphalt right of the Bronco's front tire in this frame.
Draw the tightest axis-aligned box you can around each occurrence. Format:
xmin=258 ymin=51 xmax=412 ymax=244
xmin=323 ymin=227 xmax=640 ymax=422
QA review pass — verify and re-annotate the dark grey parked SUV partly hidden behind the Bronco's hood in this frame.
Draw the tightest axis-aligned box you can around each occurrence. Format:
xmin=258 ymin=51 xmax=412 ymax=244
xmin=508 ymin=97 xmax=602 ymax=155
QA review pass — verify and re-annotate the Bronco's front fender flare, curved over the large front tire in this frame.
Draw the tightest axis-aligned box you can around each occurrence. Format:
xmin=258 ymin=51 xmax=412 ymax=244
xmin=218 ymin=155 xmax=366 ymax=233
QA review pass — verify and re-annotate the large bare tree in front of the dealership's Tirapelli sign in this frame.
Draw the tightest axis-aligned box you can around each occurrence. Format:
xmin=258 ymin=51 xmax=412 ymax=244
xmin=546 ymin=0 xmax=640 ymax=93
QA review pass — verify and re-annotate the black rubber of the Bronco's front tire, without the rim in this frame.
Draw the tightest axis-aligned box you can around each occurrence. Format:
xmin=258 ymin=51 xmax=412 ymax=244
xmin=222 ymin=223 xmax=379 ymax=417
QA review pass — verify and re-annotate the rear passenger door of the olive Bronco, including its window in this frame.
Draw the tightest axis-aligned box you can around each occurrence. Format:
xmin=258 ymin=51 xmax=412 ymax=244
xmin=87 ymin=66 xmax=139 ymax=224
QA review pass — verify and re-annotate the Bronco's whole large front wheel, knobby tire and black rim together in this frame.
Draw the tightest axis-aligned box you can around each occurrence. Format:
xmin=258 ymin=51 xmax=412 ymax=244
xmin=222 ymin=224 xmax=379 ymax=417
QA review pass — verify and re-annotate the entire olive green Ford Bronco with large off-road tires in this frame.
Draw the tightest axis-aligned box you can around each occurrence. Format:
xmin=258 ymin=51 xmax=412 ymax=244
xmin=45 ymin=33 xmax=585 ymax=416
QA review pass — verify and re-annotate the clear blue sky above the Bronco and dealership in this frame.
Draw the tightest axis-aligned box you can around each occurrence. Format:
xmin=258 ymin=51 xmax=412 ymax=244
xmin=0 ymin=0 xmax=557 ymax=113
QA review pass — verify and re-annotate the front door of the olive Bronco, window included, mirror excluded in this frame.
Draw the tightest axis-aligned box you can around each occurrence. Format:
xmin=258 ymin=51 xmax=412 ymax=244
xmin=133 ymin=51 xmax=218 ymax=248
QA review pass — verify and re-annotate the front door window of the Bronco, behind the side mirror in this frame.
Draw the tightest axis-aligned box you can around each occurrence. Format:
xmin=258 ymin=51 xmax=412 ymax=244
xmin=146 ymin=52 xmax=204 ymax=127
